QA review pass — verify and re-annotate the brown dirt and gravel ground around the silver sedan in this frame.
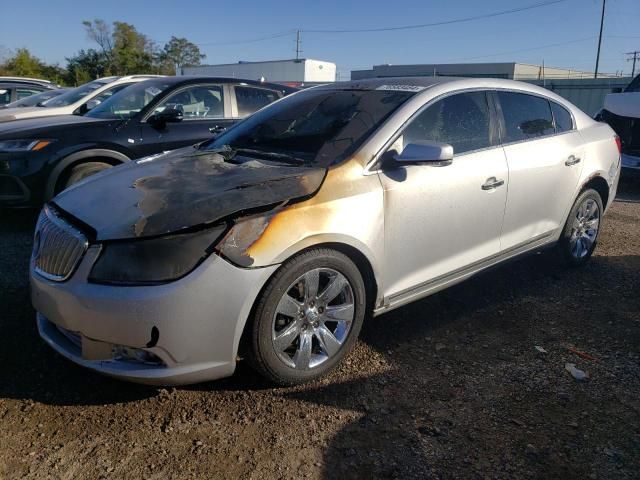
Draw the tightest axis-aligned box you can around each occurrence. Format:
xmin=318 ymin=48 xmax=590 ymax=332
xmin=0 ymin=178 xmax=640 ymax=479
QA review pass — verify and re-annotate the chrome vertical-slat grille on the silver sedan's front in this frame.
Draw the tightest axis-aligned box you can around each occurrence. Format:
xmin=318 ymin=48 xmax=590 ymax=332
xmin=31 ymin=206 xmax=89 ymax=282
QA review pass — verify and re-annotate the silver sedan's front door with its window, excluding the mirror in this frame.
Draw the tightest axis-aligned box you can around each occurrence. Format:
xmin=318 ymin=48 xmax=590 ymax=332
xmin=379 ymin=91 xmax=508 ymax=303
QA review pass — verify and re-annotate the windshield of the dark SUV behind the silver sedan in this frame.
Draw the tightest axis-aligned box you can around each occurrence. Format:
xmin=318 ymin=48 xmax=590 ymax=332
xmin=85 ymin=81 xmax=170 ymax=120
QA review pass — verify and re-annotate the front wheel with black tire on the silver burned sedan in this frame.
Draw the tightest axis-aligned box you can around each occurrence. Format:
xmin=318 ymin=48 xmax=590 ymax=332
xmin=248 ymin=248 xmax=367 ymax=385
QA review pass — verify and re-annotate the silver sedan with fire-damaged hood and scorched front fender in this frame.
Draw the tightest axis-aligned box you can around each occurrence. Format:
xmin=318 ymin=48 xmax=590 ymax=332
xmin=31 ymin=78 xmax=620 ymax=384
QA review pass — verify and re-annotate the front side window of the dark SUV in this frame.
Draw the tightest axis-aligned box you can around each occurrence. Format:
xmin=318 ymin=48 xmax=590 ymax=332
xmin=154 ymin=85 xmax=224 ymax=120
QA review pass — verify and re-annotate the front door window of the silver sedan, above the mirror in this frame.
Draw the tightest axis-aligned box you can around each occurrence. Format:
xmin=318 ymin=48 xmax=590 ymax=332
xmin=392 ymin=92 xmax=491 ymax=155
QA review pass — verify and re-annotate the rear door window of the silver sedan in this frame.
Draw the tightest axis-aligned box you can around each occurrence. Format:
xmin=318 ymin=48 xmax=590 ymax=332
xmin=497 ymin=92 xmax=555 ymax=143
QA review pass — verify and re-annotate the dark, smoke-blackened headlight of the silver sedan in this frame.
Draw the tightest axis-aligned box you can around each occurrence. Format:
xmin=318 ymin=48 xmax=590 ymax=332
xmin=89 ymin=225 xmax=226 ymax=285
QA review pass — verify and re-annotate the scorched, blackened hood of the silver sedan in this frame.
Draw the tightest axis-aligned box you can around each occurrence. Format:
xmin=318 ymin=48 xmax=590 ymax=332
xmin=53 ymin=147 xmax=326 ymax=241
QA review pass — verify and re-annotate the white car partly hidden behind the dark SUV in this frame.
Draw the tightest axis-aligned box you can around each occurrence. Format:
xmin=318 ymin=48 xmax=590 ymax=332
xmin=0 ymin=75 xmax=163 ymax=122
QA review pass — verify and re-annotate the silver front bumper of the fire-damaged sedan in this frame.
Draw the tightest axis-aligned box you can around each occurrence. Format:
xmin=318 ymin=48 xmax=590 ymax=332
xmin=31 ymin=247 xmax=277 ymax=385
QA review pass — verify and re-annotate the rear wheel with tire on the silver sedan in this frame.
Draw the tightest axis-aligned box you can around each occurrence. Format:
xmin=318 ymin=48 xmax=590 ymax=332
xmin=558 ymin=189 xmax=604 ymax=267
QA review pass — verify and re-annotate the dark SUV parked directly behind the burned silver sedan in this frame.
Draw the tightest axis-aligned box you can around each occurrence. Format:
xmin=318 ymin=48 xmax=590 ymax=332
xmin=0 ymin=77 xmax=295 ymax=206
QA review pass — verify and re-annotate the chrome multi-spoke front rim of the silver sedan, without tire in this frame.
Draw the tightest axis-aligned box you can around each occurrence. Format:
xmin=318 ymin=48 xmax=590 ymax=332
xmin=271 ymin=268 xmax=355 ymax=370
